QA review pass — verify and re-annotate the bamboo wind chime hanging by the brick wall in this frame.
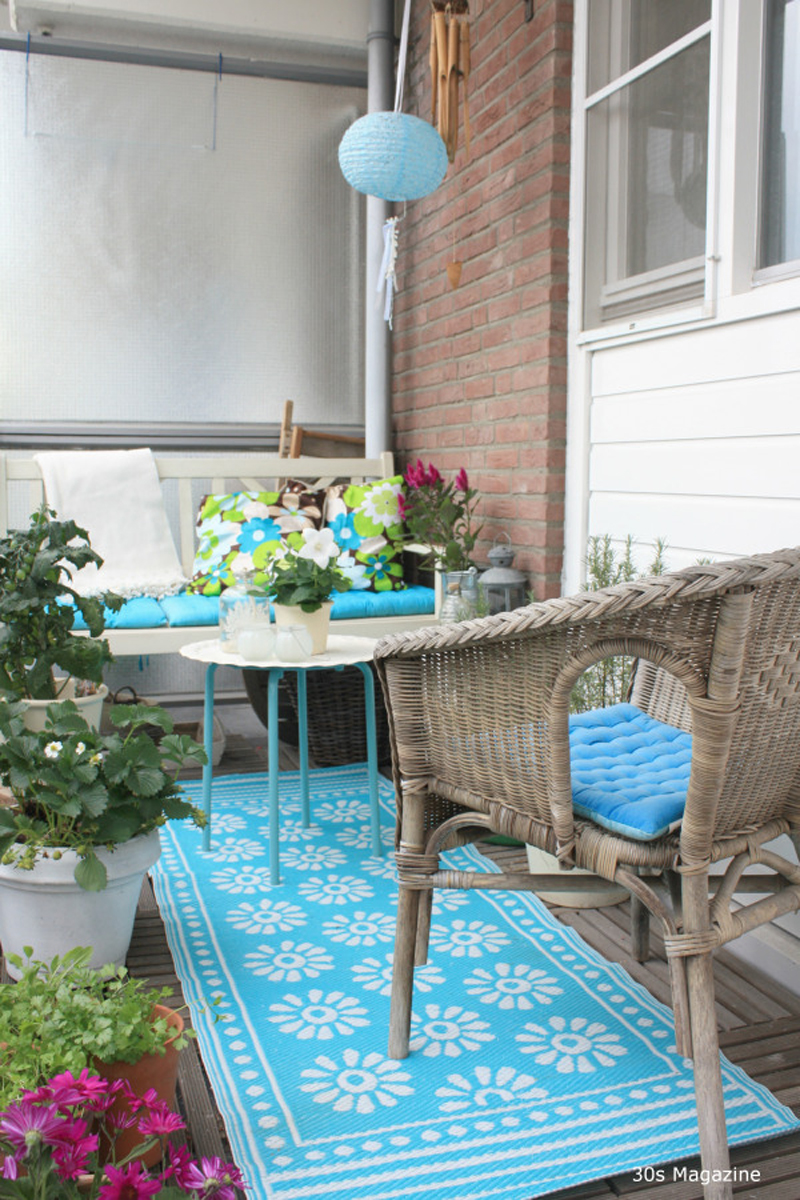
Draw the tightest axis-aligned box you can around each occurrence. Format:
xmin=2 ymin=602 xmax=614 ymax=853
xmin=429 ymin=0 xmax=470 ymax=162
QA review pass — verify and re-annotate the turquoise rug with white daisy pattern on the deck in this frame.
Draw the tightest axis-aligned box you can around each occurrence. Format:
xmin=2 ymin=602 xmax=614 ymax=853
xmin=154 ymin=766 xmax=798 ymax=1200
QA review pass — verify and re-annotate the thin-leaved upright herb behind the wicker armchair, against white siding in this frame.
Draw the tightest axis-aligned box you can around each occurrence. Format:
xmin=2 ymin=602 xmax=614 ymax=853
xmin=570 ymin=534 xmax=667 ymax=713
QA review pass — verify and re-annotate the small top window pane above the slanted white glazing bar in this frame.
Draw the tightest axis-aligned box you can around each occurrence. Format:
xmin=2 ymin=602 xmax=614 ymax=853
xmin=588 ymin=0 xmax=711 ymax=95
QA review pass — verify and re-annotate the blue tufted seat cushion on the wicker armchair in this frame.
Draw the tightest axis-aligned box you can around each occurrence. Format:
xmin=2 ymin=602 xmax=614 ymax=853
xmin=570 ymin=704 xmax=692 ymax=841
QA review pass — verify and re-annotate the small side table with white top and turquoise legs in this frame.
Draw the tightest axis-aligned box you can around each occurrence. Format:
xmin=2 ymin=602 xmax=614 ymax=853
xmin=180 ymin=634 xmax=383 ymax=883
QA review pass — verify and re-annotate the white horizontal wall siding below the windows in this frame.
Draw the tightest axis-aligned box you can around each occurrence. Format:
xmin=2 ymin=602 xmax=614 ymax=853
xmin=588 ymin=312 xmax=800 ymax=568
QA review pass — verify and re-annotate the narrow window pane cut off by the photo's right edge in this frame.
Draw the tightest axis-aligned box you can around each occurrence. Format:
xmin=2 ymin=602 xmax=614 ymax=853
xmin=760 ymin=0 xmax=800 ymax=266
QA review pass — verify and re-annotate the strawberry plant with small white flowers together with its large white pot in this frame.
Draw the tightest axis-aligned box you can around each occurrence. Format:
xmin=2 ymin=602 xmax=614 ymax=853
xmin=0 ymin=697 xmax=205 ymax=974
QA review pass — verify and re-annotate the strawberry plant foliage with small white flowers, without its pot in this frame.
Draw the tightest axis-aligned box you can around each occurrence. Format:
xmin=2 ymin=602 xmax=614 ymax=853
xmin=0 ymin=697 xmax=206 ymax=892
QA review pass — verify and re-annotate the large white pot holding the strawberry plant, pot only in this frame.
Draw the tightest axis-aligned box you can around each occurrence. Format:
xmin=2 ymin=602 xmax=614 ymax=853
xmin=0 ymin=829 xmax=161 ymax=979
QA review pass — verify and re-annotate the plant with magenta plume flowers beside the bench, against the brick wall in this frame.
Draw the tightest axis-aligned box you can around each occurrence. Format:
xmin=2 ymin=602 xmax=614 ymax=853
xmin=398 ymin=460 xmax=482 ymax=571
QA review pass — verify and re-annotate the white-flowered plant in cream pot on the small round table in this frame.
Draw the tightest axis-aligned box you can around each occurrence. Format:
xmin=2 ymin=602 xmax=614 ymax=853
xmin=266 ymin=529 xmax=351 ymax=656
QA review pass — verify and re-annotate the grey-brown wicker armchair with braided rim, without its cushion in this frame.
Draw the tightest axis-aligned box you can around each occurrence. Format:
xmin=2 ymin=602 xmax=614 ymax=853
xmin=375 ymin=548 xmax=800 ymax=1200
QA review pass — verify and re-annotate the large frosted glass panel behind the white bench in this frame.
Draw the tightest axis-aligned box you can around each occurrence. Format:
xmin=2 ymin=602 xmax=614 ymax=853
xmin=0 ymin=53 xmax=366 ymax=425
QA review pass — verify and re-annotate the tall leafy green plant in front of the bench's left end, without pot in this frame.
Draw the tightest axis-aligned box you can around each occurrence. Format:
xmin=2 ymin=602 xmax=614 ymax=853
xmin=0 ymin=505 xmax=122 ymax=700
